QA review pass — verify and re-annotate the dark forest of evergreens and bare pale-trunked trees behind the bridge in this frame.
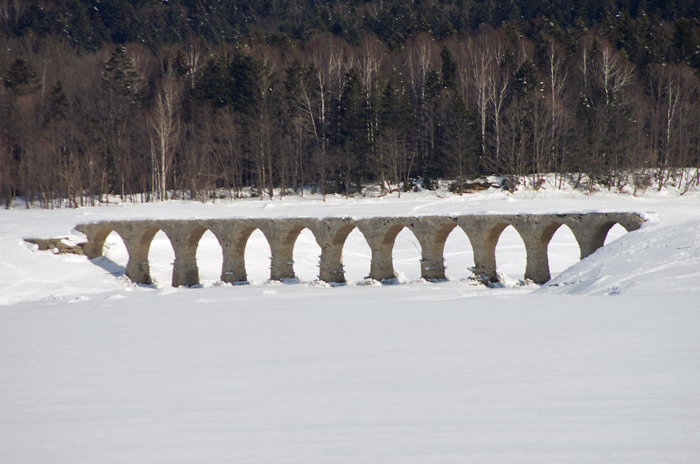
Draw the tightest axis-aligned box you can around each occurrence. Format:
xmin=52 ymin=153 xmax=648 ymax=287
xmin=0 ymin=0 xmax=700 ymax=206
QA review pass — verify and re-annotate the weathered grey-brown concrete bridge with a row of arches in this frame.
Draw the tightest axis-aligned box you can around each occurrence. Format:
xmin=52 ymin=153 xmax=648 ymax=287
xmin=76 ymin=213 xmax=644 ymax=287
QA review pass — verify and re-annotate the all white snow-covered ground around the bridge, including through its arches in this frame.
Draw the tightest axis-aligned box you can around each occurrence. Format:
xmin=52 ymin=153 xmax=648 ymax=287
xmin=0 ymin=183 xmax=700 ymax=463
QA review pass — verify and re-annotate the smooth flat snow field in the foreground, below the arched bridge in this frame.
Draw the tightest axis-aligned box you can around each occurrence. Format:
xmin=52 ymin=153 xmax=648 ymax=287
xmin=0 ymin=284 xmax=700 ymax=463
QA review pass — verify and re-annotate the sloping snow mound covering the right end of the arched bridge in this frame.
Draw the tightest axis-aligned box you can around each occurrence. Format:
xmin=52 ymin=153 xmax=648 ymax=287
xmin=536 ymin=219 xmax=700 ymax=295
